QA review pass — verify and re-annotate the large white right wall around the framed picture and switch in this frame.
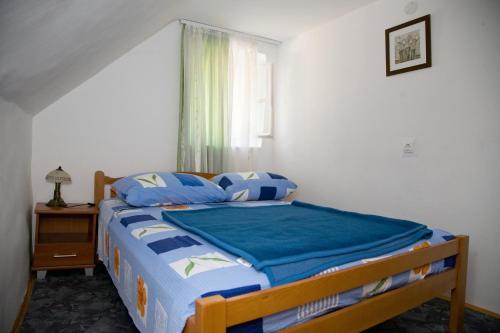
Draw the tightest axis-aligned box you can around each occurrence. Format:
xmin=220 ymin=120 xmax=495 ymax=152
xmin=274 ymin=0 xmax=500 ymax=312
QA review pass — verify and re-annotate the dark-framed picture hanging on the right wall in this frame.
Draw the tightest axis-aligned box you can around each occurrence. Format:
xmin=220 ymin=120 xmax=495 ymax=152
xmin=385 ymin=15 xmax=432 ymax=76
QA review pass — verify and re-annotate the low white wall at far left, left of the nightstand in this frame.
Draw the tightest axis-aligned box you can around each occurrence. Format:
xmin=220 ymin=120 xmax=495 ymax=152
xmin=0 ymin=99 xmax=32 ymax=332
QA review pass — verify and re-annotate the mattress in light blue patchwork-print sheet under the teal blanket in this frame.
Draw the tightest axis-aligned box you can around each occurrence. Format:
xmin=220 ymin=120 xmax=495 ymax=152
xmin=98 ymin=199 xmax=453 ymax=333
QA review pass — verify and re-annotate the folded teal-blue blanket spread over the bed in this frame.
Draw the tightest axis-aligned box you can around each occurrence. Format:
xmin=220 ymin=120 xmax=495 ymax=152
xmin=162 ymin=201 xmax=432 ymax=285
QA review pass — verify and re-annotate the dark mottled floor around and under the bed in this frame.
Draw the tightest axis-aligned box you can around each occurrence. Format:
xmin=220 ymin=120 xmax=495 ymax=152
xmin=21 ymin=265 xmax=500 ymax=333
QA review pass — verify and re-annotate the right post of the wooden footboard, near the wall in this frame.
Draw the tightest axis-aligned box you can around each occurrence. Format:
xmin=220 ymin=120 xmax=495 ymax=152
xmin=448 ymin=236 xmax=469 ymax=333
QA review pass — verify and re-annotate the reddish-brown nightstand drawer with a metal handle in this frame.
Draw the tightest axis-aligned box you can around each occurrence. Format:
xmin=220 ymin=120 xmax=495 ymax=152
xmin=33 ymin=244 xmax=94 ymax=269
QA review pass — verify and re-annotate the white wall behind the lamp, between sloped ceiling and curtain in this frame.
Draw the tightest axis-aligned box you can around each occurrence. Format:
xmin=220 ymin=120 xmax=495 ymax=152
xmin=32 ymin=23 xmax=184 ymax=202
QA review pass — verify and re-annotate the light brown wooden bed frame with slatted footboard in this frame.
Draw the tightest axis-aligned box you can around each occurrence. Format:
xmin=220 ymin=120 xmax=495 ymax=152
xmin=94 ymin=171 xmax=469 ymax=333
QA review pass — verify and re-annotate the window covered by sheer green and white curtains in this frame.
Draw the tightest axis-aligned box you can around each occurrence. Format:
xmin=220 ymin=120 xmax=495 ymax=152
xmin=178 ymin=25 xmax=276 ymax=173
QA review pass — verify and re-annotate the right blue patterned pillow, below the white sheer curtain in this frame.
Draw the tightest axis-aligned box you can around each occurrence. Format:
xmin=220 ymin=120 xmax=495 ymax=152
xmin=212 ymin=172 xmax=297 ymax=201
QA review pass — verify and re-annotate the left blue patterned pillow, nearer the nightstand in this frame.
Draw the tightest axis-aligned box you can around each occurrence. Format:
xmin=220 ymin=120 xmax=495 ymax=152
xmin=113 ymin=172 xmax=226 ymax=207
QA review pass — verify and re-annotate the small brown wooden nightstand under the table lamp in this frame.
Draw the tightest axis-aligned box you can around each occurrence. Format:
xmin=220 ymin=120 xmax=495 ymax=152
xmin=31 ymin=203 xmax=97 ymax=280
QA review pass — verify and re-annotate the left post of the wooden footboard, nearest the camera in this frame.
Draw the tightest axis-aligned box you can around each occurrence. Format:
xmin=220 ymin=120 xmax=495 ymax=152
xmin=194 ymin=295 xmax=226 ymax=333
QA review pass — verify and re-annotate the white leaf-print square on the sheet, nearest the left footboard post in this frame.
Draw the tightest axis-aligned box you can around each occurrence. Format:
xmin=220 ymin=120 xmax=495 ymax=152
xmin=170 ymin=252 xmax=238 ymax=279
